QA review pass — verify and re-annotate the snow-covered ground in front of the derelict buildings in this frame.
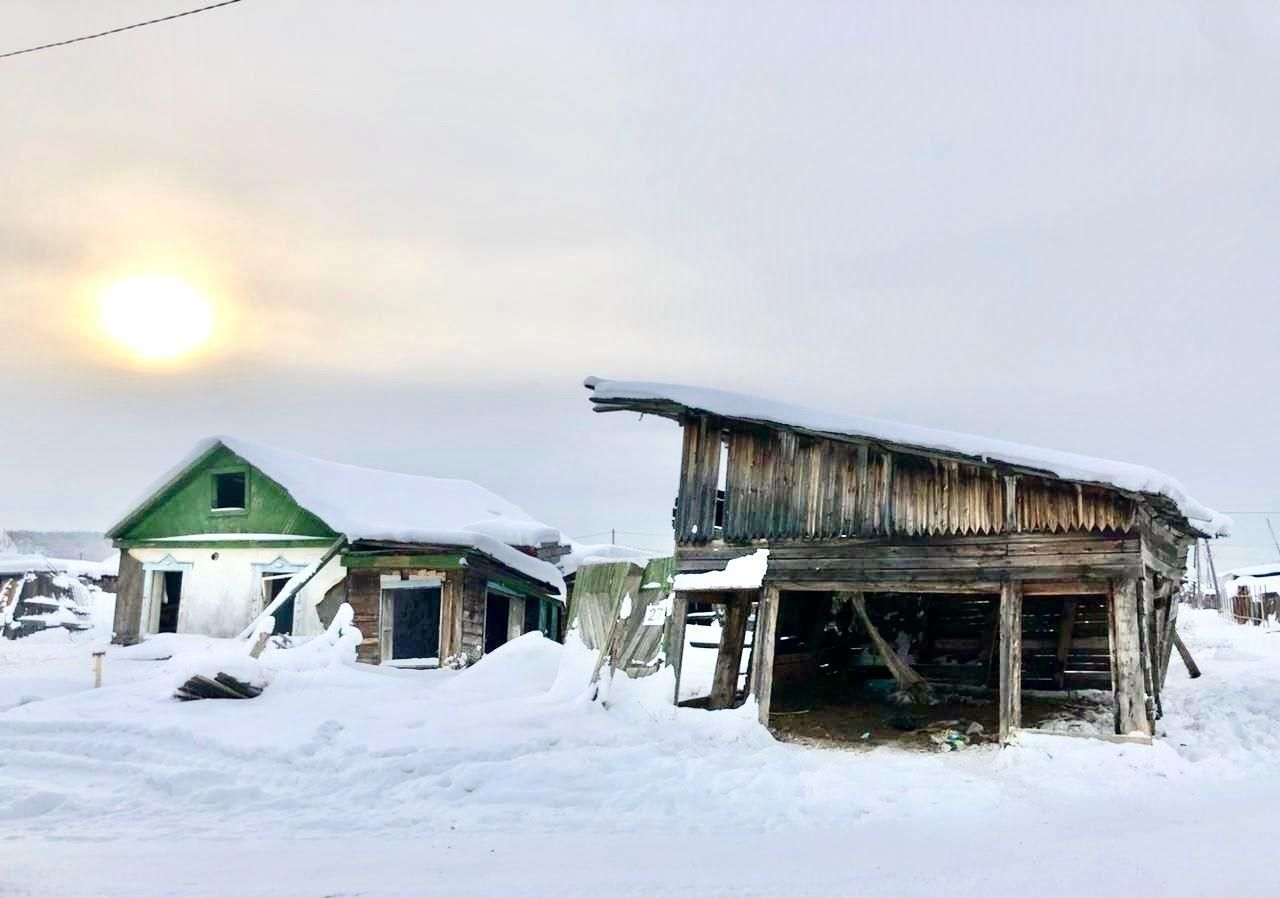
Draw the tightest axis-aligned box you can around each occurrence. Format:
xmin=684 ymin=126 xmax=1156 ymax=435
xmin=0 ymin=611 xmax=1280 ymax=898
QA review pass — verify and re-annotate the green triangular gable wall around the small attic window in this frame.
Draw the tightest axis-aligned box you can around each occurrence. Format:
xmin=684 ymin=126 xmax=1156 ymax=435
xmin=110 ymin=445 xmax=338 ymax=542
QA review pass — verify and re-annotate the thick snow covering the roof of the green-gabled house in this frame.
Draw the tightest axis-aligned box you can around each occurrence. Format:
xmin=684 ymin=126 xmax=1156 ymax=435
xmin=108 ymin=436 xmax=564 ymax=597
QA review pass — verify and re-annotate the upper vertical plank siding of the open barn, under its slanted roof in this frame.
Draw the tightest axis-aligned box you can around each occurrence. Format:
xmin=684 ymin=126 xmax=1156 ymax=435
xmin=676 ymin=416 xmax=1137 ymax=544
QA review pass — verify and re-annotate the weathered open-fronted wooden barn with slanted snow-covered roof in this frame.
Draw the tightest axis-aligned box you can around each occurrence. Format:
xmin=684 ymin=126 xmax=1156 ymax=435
xmin=586 ymin=379 xmax=1229 ymax=738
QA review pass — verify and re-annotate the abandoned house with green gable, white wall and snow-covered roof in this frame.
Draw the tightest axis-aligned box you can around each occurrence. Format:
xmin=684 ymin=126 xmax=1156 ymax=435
xmin=108 ymin=437 xmax=567 ymax=665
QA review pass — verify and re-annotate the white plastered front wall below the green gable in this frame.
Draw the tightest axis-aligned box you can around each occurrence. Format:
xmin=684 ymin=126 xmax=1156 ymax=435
xmin=128 ymin=544 xmax=347 ymax=637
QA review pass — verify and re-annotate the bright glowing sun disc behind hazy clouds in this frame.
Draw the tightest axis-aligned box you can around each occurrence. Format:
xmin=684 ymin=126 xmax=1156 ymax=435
xmin=99 ymin=276 xmax=214 ymax=362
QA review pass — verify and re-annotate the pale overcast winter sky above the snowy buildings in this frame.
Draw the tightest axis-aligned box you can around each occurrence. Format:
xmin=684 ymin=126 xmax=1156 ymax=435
xmin=0 ymin=0 xmax=1280 ymax=568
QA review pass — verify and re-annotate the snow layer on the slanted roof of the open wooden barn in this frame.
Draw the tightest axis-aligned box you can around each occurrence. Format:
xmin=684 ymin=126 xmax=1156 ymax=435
xmin=584 ymin=377 xmax=1231 ymax=537
